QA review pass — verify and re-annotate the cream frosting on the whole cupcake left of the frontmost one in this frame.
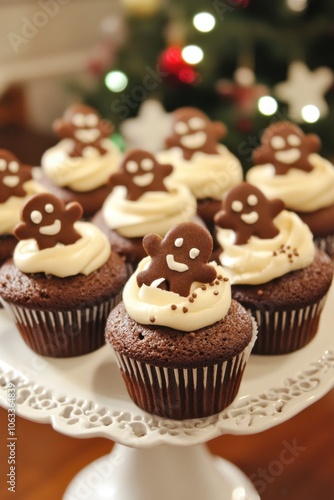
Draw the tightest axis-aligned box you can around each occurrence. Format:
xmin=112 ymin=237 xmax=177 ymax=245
xmin=14 ymin=221 xmax=111 ymax=278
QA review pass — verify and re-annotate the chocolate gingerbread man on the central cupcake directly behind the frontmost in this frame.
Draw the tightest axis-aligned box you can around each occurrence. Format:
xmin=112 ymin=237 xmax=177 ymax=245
xmin=109 ymin=149 xmax=173 ymax=201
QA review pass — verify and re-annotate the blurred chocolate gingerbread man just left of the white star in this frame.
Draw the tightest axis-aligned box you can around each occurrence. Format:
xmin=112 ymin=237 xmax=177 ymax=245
xmin=53 ymin=104 xmax=114 ymax=157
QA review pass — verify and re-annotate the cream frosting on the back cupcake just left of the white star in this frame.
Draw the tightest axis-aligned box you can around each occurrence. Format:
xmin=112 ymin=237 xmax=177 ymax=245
xmin=41 ymin=139 xmax=121 ymax=192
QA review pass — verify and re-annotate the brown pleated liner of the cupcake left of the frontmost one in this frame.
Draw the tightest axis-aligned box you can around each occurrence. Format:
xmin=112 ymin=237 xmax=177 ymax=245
xmin=2 ymin=293 xmax=122 ymax=358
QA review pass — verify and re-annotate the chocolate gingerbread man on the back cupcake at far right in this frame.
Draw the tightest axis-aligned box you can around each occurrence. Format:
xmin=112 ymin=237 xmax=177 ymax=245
xmin=253 ymin=122 xmax=321 ymax=175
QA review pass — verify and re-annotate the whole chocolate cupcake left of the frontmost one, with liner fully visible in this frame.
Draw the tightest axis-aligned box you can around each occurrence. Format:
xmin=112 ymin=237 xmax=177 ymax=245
xmin=0 ymin=193 xmax=127 ymax=358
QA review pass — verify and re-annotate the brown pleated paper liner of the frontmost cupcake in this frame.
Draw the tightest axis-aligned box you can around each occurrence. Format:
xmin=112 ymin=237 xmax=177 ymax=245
xmin=113 ymin=334 xmax=255 ymax=420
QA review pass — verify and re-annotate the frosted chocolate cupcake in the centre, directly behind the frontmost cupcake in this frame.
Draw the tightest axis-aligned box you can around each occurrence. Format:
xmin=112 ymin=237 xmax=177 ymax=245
xmin=92 ymin=149 xmax=203 ymax=267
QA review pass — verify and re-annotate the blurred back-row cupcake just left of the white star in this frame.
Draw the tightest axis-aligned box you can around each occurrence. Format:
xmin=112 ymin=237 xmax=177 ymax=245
xmin=41 ymin=104 xmax=121 ymax=218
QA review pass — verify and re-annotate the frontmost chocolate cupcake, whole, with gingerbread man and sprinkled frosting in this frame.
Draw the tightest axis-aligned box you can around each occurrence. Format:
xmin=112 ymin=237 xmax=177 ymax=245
xmin=105 ymin=222 xmax=256 ymax=420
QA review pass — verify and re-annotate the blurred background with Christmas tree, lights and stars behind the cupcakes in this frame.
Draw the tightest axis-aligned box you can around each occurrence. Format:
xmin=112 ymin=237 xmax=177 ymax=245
xmin=0 ymin=0 xmax=334 ymax=170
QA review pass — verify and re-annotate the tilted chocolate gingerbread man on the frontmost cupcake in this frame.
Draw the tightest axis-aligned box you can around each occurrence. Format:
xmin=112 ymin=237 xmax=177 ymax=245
xmin=137 ymin=222 xmax=217 ymax=297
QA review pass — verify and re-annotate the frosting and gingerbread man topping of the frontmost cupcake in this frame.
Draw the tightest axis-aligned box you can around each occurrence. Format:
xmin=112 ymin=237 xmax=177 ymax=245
xmin=123 ymin=222 xmax=231 ymax=332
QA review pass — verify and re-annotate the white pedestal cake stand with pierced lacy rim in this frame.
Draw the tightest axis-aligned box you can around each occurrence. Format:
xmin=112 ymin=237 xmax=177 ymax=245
xmin=0 ymin=287 xmax=334 ymax=500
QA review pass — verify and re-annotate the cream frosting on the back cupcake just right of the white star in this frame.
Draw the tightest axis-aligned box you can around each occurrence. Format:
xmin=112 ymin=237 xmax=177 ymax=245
xmin=156 ymin=144 xmax=243 ymax=200
